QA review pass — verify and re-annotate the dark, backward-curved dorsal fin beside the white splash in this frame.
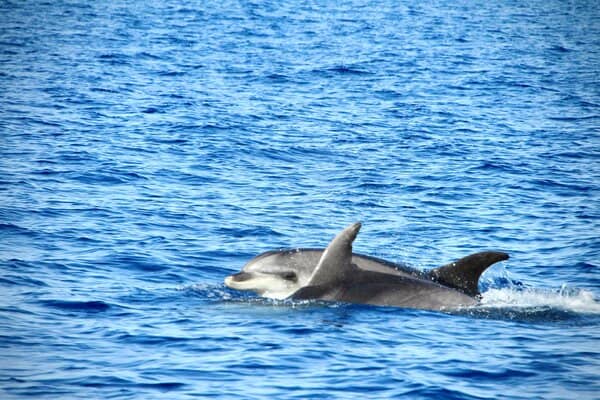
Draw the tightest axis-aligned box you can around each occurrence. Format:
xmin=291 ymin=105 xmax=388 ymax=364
xmin=429 ymin=251 xmax=508 ymax=296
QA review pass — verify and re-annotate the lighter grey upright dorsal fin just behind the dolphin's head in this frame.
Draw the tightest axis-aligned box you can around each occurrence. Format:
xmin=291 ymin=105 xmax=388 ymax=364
xmin=308 ymin=222 xmax=361 ymax=286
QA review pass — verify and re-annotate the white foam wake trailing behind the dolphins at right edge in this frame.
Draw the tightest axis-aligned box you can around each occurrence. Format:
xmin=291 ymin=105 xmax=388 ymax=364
xmin=481 ymin=286 xmax=600 ymax=314
